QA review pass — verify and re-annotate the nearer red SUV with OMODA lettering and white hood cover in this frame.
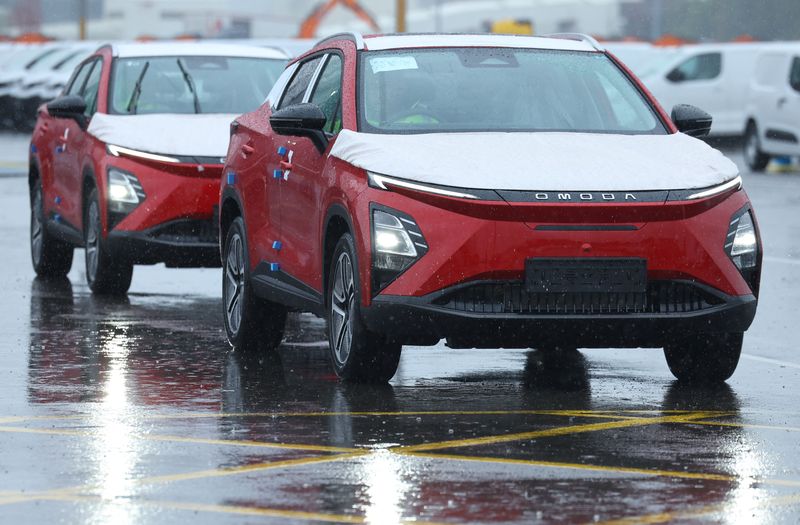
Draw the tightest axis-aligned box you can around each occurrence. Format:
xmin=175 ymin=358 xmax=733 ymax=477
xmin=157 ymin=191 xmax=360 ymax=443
xmin=220 ymin=34 xmax=761 ymax=381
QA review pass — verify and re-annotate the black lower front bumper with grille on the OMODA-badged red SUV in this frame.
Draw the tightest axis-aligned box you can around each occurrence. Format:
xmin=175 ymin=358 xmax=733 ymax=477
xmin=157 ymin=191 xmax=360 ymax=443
xmin=362 ymin=281 xmax=757 ymax=348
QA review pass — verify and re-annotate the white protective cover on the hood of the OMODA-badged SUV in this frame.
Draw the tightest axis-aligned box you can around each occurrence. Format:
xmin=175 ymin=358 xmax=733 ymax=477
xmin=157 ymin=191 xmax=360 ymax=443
xmin=331 ymin=130 xmax=739 ymax=191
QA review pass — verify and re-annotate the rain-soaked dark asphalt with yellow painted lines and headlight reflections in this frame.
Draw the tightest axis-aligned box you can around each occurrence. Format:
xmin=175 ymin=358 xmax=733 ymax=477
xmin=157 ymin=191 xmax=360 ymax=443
xmin=0 ymin=136 xmax=800 ymax=525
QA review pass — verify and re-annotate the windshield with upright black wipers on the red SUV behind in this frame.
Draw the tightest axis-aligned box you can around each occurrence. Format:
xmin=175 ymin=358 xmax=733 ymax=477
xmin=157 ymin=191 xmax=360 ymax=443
xmin=109 ymin=56 xmax=286 ymax=114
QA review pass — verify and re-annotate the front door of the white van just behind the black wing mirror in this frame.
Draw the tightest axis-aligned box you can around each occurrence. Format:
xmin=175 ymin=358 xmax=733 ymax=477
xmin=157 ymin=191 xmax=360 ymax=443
xmin=658 ymin=51 xmax=730 ymax=131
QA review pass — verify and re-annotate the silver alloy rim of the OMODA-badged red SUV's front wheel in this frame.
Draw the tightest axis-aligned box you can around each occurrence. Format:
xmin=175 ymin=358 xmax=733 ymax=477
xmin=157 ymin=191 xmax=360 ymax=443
xmin=331 ymin=252 xmax=356 ymax=366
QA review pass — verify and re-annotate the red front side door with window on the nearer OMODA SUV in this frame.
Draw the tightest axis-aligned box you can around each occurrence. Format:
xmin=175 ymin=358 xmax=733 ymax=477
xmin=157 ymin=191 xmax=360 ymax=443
xmin=281 ymin=52 xmax=343 ymax=293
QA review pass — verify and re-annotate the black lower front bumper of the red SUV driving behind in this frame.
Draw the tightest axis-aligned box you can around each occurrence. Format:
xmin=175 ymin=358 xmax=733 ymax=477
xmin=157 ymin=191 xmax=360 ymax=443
xmin=106 ymin=219 xmax=220 ymax=268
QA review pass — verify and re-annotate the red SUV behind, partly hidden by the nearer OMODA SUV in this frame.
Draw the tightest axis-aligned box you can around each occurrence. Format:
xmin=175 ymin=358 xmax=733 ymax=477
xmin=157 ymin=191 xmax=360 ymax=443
xmin=30 ymin=43 xmax=286 ymax=293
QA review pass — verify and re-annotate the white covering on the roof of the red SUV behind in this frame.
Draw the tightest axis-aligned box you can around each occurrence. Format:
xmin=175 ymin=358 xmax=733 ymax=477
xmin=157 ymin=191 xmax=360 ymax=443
xmin=111 ymin=42 xmax=288 ymax=59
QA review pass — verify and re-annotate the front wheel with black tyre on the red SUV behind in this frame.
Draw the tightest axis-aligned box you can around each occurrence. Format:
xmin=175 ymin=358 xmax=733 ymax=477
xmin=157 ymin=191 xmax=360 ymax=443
xmin=83 ymin=188 xmax=133 ymax=295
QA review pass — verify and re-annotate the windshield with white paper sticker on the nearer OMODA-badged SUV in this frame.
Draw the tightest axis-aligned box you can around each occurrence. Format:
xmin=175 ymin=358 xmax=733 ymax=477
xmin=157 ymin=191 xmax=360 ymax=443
xmin=360 ymin=48 xmax=666 ymax=134
